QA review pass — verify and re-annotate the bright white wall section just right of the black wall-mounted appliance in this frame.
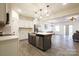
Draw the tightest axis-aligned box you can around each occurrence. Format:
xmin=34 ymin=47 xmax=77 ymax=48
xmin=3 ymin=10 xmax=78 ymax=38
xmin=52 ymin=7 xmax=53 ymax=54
xmin=10 ymin=10 xmax=19 ymax=36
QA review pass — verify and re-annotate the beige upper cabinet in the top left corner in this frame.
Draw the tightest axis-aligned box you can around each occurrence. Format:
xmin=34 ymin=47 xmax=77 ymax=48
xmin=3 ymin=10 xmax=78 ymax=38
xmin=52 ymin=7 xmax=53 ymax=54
xmin=0 ymin=3 xmax=6 ymax=25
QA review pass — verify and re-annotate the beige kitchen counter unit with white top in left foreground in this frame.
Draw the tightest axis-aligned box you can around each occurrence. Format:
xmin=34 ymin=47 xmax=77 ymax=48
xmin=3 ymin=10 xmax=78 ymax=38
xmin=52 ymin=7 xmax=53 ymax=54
xmin=0 ymin=35 xmax=19 ymax=56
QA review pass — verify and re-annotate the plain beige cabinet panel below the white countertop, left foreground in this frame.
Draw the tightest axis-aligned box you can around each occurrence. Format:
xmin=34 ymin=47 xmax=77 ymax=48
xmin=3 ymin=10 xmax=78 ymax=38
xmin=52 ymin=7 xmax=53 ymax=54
xmin=0 ymin=39 xmax=18 ymax=56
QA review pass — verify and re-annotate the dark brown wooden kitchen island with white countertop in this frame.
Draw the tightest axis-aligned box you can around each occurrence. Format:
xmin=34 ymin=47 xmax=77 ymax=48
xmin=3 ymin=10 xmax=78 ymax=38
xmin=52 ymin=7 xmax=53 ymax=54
xmin=28 ymin=33 xmax=52 ymax=51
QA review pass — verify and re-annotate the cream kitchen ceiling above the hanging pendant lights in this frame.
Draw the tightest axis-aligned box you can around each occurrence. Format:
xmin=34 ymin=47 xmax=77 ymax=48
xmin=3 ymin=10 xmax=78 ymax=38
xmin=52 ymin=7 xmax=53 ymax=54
xmin=11 ymin=3 xmax=79 ymax=17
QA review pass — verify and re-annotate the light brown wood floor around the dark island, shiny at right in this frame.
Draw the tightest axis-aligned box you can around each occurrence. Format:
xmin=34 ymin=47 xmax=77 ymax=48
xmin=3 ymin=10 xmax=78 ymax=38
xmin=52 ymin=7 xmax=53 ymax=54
xmin=19 ymin=35 xmax=79 ymax=56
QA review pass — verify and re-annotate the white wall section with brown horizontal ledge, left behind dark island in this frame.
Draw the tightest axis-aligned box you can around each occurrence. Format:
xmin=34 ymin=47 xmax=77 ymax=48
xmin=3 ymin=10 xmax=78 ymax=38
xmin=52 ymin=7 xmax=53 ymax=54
xmin=19 ymin=15 xmax=33 ymax=40
